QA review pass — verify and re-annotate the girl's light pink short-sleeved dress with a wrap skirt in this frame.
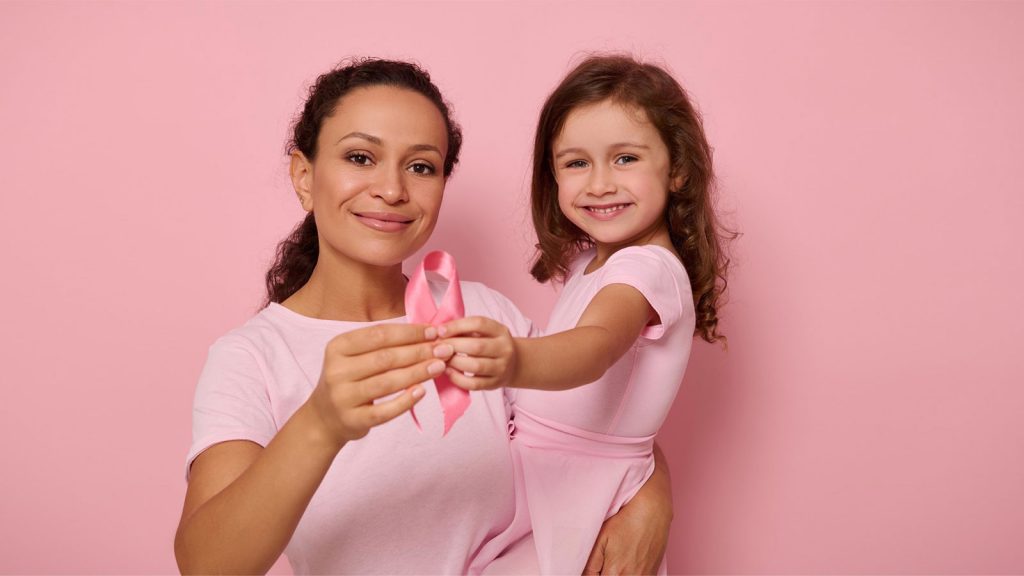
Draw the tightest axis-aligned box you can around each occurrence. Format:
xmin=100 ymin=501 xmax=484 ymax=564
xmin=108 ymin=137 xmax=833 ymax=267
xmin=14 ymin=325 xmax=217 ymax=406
xmin=486 ymin=246 xmax=694 ymax=574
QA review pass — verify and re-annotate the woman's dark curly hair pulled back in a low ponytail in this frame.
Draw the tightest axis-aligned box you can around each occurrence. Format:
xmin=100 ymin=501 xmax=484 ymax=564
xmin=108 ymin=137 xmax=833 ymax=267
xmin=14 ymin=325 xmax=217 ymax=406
xmin=263 ymin=58 xmax=462 ymax=306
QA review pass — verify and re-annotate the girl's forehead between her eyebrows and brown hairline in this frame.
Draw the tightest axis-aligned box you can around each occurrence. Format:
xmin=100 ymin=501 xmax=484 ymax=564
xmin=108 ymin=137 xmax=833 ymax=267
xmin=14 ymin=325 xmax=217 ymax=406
xmin=555 ymin=100 xmax=659 ymax=146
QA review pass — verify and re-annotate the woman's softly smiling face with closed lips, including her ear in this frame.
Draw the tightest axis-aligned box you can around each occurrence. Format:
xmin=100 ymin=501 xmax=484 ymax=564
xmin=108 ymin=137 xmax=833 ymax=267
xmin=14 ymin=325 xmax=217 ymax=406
xmin=292 ymin=86 xmax=447 ymax=266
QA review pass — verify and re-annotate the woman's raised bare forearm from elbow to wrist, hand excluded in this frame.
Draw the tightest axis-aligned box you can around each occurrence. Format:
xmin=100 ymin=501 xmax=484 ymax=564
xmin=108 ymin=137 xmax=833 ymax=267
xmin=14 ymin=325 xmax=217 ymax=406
xmin=174 ymin=404 xmax=339 ymax=574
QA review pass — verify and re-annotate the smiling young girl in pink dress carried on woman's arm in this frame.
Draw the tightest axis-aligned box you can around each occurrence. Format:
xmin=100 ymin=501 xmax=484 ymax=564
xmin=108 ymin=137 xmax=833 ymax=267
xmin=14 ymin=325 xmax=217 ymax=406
xmin=440 ymin=56 xmax=728 ymax=574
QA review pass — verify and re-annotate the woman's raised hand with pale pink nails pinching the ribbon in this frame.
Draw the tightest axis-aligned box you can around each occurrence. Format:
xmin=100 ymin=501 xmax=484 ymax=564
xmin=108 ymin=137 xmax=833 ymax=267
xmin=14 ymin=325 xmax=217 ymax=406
xmin=308 ymin=324 xmax=452 ymax=449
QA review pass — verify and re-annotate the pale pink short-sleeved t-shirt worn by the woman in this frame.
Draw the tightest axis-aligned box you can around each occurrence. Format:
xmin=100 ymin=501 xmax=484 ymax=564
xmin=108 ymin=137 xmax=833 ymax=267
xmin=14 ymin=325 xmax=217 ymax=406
xmin=186 ymin=282 xmax=530 ymax=574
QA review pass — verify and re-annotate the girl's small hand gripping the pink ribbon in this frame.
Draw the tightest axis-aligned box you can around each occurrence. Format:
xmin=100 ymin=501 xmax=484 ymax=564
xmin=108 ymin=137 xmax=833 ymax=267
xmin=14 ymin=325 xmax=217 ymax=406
xmin=437 ymin=316 xmax=518 ymax=390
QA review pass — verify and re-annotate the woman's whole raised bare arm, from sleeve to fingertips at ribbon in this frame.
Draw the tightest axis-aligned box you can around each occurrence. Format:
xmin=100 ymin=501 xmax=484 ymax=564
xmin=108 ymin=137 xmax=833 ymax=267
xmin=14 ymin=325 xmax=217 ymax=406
xmin=174 ymin=324 xmax=446 ymax=574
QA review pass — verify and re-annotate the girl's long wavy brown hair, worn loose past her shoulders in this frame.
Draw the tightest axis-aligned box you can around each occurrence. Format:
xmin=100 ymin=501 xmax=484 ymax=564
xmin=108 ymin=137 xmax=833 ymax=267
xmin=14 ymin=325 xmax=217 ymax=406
xmin=530 ymin=54 xmax=736 ymax=342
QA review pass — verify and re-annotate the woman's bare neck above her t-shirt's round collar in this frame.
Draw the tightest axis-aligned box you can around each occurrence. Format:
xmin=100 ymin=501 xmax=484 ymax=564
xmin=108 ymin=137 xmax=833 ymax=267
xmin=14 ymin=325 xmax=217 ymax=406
xmin=282 ymin=246 xmax=406 ymax=322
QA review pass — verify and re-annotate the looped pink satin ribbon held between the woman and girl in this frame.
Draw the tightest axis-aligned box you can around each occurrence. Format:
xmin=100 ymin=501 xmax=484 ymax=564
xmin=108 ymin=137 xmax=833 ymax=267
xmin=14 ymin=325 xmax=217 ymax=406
xmin=406 ymin=250 xmax=469 ymax=436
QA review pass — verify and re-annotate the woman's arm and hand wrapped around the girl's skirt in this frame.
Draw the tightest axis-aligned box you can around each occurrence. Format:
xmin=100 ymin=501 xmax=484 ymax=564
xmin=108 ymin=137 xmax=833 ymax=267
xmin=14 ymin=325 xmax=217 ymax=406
xmin=584 ymin=444 xmax=673 ymax=574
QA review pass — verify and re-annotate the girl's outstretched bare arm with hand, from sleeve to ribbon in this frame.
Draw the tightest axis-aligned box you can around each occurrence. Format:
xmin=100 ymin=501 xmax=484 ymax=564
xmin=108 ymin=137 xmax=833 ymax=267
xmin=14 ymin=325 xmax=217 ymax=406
xmin=439 ymin=284 xmax=656 ymax=390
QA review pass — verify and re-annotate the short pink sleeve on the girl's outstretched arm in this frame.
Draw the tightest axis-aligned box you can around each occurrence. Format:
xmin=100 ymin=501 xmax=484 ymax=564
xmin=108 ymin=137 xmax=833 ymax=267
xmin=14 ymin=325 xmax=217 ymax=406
xmin=597 ymin=246 xmax=689 ymax=340
